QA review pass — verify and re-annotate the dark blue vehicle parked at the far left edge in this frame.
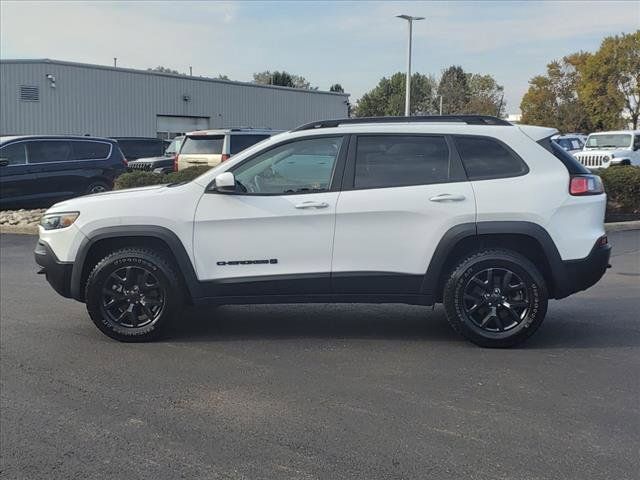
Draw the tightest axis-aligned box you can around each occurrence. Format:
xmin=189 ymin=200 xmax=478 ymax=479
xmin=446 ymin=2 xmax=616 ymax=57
xmin=0 ymin=135 xmax=126 ymax=208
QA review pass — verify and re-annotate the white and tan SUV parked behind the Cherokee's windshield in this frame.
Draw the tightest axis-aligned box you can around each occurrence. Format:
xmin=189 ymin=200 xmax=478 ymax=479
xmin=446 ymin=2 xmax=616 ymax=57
xmin=176 ymin=128 xmax=280 ymax=170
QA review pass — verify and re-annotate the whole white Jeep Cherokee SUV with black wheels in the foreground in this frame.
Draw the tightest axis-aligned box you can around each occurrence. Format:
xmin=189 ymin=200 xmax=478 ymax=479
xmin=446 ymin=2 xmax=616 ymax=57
xmin=35 ymin=116 xmax=610 ymax=347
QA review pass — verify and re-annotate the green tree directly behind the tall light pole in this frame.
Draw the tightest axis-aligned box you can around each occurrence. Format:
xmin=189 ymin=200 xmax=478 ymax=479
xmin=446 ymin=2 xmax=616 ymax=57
xmin=355 ymin=72 xmax=436 ymax=117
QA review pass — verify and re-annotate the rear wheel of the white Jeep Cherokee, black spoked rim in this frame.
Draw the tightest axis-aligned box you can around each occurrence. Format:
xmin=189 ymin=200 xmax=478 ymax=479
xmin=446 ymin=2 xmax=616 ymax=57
xmin=443 ymin=250 xmax=548 ymax=348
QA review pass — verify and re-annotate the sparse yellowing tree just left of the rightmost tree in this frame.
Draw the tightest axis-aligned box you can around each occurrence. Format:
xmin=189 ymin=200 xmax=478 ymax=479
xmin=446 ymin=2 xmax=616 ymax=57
xmin=520 ymin=52 xmax=594 ymax=132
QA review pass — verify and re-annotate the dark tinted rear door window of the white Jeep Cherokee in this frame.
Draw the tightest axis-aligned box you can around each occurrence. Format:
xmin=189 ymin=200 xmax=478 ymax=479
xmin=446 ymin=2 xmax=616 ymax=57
xmin=354 ymin=135 xmax=450 ymax=188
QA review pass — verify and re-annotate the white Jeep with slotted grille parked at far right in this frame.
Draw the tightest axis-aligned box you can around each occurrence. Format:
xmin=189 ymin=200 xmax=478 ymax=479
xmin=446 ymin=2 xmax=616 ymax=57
xmin=575 ymin=130 xmax=640 ymax=168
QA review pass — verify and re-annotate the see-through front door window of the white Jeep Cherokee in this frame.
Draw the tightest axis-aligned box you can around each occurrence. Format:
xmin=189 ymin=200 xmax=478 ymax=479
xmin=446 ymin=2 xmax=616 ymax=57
xmin=233 ymin=137 xmax=342 ymax=194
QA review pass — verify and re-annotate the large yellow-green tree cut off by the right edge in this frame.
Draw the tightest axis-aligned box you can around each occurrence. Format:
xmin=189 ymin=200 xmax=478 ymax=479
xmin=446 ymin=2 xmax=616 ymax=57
xmin=578 ymin=30 xmax=640 ymax=130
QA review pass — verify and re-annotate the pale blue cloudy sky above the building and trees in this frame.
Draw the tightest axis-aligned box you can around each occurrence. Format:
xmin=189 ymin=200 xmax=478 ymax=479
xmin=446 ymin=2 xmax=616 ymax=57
xmin=0 ymin=0 xmax=640 ymax=112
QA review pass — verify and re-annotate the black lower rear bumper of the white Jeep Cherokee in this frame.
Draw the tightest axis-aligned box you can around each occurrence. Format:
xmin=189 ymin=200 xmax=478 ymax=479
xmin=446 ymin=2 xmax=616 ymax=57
xmin=556 ymin=244 xmax=611 ymax=298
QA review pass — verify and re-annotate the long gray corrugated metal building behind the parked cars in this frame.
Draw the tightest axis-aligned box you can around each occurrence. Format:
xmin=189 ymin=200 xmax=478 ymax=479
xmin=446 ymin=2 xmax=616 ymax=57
xmin=0 ymin=60 xmax=349 ymax=138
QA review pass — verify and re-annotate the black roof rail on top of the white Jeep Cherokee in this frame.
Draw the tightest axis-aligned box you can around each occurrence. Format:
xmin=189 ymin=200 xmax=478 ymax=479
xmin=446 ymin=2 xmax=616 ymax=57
xmin=292 ymin=115 xmax=513 ymax=132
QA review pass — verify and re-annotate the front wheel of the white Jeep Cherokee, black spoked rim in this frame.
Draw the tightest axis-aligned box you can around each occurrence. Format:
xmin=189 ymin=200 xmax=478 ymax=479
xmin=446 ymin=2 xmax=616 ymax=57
xmin=85 ymin=248 xmax=183 ymax=342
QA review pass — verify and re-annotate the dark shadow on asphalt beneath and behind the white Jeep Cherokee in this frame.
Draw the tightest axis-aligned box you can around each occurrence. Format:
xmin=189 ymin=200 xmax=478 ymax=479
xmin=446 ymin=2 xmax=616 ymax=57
xmin=166 ymin=304 xmax=640 ymax=350
